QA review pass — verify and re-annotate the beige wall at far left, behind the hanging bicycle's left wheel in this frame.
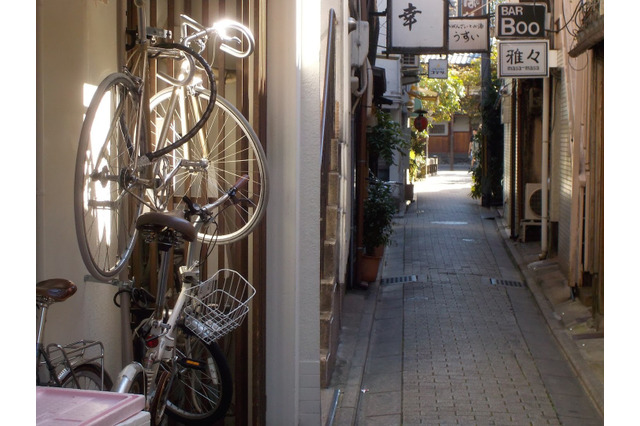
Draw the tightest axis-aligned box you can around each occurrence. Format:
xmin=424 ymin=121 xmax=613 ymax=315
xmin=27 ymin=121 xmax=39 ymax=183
xmin=36 ymin=0 xmax=121 ymax=378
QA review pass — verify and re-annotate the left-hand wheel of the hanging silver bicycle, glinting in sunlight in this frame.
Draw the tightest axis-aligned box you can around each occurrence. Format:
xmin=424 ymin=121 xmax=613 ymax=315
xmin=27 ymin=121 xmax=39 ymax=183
xmin=74 ymin=73 xmax=144 ymax=281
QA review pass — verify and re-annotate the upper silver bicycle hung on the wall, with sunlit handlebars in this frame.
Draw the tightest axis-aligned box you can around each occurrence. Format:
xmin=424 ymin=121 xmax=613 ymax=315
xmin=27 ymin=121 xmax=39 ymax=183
xmin=74 ymin=0 xmax=267 ymax=281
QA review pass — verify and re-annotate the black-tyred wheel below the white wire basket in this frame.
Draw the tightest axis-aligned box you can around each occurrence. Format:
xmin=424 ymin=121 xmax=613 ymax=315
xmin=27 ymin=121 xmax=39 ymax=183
xmin=165 ymin=327 xmax=233 ymax=425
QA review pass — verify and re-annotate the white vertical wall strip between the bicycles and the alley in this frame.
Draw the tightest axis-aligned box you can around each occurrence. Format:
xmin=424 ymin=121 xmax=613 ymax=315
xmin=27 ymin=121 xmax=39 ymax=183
xmin=266 ymin=0 xmax=326 ymax=425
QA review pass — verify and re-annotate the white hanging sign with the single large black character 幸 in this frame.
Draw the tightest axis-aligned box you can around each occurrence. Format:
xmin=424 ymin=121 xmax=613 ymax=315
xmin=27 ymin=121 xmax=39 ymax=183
xmin=387 ymin=0 xmax=449 ymax=55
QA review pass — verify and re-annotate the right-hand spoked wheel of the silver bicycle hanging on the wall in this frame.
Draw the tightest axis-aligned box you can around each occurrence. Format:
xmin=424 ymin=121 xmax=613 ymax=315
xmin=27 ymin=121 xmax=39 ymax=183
xmin=150 ymin=89 xmax=268 ymax=244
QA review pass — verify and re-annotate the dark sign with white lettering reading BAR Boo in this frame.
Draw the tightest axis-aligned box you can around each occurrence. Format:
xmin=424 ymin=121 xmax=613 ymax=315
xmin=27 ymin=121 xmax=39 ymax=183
xmin=496 ymin=3 xmax=547 ymax=38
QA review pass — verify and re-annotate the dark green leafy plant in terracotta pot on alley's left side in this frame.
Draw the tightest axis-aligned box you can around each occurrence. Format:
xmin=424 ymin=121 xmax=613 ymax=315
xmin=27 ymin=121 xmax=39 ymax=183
xmin=361 ymin=177 xmax=397 ymax=282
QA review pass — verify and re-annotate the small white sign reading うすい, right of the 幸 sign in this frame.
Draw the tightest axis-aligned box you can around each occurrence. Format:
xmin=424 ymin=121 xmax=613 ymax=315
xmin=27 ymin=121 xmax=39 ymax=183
xmin=449 ymin=18 xmax=489 ymax=53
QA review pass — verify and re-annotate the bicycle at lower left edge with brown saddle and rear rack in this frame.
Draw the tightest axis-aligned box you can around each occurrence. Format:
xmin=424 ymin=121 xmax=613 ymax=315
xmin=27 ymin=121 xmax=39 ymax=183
xmin=36 ymin=278 xmax=112 ymax=390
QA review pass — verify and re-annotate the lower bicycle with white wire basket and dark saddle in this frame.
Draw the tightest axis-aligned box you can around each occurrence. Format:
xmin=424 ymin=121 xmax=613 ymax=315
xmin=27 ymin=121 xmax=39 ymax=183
xmin=109 ymin=177 xmax=255 ymax=425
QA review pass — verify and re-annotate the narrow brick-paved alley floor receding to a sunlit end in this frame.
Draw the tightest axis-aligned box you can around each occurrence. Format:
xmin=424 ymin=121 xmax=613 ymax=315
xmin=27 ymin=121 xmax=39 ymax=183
xmin=323 ymin=169 xmax=603 ymax=426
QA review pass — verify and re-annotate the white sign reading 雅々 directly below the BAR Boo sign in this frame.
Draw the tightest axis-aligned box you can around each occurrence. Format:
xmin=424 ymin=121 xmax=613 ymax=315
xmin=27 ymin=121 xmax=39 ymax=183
xmin=498 ymin=40 xmax=549 ymax=78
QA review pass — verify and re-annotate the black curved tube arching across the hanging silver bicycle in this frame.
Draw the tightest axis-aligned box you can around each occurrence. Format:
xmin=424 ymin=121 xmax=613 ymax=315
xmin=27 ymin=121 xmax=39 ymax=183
xmin=145 ymin=43 xmax=217 ymax=160
